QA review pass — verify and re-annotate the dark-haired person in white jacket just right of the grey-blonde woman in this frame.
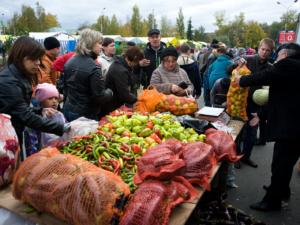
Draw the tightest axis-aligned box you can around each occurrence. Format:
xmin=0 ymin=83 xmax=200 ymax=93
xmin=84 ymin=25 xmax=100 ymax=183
xmin=97 ymin=38 xmax=116 ymax=79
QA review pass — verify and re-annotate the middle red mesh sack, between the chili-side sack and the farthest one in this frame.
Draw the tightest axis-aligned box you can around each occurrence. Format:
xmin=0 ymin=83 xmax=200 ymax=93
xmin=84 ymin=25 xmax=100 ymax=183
xmin=180 ymin=142 xmax=217 ymax=190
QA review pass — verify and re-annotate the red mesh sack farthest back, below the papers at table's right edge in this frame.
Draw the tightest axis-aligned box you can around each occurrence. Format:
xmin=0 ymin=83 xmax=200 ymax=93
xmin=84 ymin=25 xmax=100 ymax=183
xmin=205 ymin=128 xmax=242 ymax=162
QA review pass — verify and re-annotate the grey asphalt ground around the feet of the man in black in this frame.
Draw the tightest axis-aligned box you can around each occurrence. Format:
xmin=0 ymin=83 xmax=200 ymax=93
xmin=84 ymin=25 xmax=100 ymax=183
xmin=227 ymin=143 xmax=300 ymax=225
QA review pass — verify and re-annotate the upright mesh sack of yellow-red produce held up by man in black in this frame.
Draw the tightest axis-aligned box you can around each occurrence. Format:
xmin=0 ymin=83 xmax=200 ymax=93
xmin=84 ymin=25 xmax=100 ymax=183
xmin=227 ymin=65 xmax=251 ymax=121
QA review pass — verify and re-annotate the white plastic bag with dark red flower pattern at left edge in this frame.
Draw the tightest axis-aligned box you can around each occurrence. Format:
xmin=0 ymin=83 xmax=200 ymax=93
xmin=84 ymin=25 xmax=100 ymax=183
xmin=0 ymin=114 xmax=20 ymax=187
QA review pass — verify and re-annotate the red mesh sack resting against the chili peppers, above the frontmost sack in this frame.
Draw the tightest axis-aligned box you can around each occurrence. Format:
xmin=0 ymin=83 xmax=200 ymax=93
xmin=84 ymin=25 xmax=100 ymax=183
xmin=134 ymin=140 xmax=185 ymax=184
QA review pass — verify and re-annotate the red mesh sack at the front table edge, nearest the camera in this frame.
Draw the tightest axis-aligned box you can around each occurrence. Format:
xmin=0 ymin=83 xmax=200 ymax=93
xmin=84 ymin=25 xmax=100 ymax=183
xmin=119 ymin=177 xmax=197 ymax=225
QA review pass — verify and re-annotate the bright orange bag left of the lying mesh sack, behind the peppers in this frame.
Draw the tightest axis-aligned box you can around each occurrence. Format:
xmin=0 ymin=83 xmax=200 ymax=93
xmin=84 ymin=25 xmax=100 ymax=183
xmin=134 ymin=86 xmax=164 ymax=113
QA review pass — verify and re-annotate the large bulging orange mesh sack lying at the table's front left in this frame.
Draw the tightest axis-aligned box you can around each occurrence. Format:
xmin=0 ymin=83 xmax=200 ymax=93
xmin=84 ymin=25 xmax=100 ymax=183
xmin=13 ymin=148 xmax=130 ymax=225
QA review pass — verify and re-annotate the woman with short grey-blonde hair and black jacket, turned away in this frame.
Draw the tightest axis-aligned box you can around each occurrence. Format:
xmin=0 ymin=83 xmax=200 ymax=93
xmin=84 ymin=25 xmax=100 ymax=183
xmin=63 ymin=29 xmax=113 ymax=121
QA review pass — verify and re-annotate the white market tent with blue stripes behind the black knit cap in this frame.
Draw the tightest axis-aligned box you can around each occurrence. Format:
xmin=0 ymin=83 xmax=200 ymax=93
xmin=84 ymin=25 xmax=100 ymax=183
xmin=29 ymin=32 xmax=76 ymax=54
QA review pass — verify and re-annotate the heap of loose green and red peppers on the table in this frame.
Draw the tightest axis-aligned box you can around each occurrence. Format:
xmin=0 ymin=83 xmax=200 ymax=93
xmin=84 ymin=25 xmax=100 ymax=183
xmin=61 ymin=110 xmax=205 ymax=190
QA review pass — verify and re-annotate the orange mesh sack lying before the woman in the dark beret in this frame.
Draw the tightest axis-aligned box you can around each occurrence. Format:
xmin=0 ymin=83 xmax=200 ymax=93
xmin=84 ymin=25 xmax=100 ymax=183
xmin=156 ymin=95 xmax=198 ymax=116
